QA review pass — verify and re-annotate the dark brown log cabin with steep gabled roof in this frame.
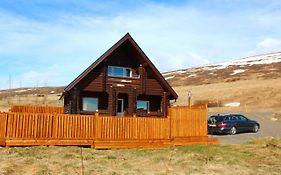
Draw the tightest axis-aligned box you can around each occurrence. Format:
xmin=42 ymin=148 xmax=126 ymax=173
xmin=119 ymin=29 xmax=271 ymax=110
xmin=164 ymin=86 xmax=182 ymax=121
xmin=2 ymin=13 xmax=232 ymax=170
xmin=63 ymin=33 xmax=178 ymax=117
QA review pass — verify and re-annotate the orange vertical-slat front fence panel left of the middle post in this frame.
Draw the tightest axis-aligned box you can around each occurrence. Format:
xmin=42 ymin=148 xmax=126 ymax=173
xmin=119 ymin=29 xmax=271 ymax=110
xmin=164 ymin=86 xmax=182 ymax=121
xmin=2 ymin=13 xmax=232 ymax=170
xmin=4 ymin=113 xmax=94 ymax=139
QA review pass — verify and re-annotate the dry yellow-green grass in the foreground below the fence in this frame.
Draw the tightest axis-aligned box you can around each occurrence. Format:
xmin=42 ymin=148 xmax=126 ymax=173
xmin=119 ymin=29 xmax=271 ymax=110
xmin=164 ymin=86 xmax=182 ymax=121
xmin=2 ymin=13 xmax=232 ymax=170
xmin=0 ymin=138 xmax=281 ymax=175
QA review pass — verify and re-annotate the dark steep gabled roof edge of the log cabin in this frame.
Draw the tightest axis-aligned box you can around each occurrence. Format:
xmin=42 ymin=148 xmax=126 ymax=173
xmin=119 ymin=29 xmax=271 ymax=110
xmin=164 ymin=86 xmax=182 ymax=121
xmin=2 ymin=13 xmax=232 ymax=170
xmin=64 ymin=33 xmax=178 ymax=99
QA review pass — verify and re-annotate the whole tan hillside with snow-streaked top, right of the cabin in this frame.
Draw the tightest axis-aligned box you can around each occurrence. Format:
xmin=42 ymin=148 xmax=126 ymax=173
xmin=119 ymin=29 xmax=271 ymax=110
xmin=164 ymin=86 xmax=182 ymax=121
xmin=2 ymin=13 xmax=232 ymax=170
xmin=163 ymin=52 xmax=281 ymax=110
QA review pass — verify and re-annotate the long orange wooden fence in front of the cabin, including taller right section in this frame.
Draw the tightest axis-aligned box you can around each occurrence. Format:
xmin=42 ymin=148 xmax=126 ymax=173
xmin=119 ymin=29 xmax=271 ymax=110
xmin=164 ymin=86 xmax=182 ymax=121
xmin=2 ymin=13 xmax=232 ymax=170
xmin=0 ymin=107 xmax=218 ymax=148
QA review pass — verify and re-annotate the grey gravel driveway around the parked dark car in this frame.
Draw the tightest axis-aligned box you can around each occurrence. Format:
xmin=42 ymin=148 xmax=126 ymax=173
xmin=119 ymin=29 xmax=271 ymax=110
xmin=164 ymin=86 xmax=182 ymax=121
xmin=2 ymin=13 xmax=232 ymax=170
xmin=209 ymin=112 xmax=281 ymax=144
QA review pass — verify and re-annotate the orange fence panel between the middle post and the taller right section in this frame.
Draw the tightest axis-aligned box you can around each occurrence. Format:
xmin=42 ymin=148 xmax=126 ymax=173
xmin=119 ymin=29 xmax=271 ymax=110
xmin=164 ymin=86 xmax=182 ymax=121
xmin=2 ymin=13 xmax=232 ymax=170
xmin=96 ymin=116 xmax=170 ymax=140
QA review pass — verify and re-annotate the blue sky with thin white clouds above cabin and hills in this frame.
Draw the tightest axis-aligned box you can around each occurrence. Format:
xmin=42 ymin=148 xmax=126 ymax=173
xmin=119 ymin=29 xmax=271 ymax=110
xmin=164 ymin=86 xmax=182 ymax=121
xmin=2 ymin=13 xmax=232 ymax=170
xmin=0 ymin=0 xmax=281 ymax=89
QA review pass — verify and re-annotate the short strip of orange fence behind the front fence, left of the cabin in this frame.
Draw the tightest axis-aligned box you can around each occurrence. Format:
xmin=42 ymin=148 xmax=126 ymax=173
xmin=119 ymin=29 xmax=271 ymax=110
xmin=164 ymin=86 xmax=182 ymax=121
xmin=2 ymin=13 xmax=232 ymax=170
xmin=11 ymin=105 xmax=64 ymax=114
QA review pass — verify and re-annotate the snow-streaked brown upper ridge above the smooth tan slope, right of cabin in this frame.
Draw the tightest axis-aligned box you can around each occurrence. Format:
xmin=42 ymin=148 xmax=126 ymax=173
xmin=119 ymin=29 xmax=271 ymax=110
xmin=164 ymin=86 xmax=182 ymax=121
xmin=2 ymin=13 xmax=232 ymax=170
xmin=162 ymin=52 xmax=281 ymax=86
